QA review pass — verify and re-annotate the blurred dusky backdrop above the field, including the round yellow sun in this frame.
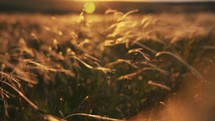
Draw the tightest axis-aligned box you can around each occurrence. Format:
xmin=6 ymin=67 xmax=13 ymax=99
xmin=0 ymin=0 xmax=215 ymax=13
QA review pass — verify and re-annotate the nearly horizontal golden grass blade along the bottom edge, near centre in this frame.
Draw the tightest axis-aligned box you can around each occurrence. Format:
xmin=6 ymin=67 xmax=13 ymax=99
xmin=65 ymin=113 xmax=127 ymax=121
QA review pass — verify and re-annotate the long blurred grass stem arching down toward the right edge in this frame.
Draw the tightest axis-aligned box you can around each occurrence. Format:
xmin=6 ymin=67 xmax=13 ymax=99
xmin=155 ymin=51 xmax=206 ymax=82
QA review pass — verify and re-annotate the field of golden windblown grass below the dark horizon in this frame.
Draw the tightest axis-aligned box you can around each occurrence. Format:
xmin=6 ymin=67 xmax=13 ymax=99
xmin=0 ymin=10 xmax=215 ymax=121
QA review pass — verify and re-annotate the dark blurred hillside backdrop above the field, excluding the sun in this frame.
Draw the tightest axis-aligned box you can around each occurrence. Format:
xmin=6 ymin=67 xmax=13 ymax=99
xmin=0 ymin=0 xmax=215 ymax=13
